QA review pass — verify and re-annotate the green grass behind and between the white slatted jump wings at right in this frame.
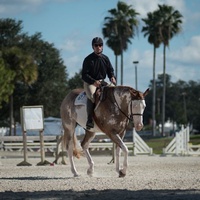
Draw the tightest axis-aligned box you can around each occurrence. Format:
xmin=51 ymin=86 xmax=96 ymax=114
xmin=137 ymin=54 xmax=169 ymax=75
xmin=143 ymin=135 xmax=200 ymax=154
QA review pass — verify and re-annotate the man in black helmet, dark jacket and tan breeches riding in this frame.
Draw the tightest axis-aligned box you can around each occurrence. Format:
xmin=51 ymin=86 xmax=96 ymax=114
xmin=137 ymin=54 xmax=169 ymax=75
xmin=82 ymin=37 xmax=116 ymax=129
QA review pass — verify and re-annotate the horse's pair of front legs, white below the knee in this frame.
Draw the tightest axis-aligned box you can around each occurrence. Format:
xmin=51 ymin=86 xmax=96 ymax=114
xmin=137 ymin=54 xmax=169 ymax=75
xmin=110 ymin=134 xmax=128 ymax=177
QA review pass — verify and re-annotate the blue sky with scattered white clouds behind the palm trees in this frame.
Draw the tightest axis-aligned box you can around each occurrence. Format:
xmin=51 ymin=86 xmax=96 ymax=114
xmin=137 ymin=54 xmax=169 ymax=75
xmin=0 ymin=0 xmax=200 ymax=91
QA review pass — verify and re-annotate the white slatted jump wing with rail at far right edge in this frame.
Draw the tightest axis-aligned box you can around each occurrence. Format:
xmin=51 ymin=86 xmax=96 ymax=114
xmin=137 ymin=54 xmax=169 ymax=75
xmin=163 ymin=126 xmax=200 ymax=156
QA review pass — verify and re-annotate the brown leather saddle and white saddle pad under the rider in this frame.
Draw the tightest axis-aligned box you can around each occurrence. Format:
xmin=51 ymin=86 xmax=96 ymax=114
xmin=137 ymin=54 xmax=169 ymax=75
xmin=74 ymin=81 xmax=109 ymax=109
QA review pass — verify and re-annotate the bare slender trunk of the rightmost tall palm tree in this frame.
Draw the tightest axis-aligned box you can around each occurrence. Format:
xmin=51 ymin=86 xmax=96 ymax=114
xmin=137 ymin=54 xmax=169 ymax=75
xmin=162 ymin=44 xmax=166 ymax=136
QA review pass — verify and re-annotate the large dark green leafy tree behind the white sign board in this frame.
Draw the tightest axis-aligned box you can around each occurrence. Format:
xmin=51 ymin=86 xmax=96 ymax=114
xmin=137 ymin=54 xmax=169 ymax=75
xmin=0 ymin=19 xmax=68 ymax=134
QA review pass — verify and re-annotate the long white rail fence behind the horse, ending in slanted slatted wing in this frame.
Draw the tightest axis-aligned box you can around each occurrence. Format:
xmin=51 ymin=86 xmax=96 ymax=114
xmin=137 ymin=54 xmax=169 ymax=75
xmin=0 ymin=131 xmax=152 ymax=162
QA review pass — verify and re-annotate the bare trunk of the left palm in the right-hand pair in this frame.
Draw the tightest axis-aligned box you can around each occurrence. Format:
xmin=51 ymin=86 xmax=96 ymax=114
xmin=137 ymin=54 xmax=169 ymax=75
xmin=152 ymin=46 xmax=156 ymax=136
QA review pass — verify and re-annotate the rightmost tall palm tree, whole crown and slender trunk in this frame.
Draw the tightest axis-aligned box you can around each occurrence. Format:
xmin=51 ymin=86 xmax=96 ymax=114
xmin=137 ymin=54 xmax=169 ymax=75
xmin=158 ymin=4 xmax=183 ymax=134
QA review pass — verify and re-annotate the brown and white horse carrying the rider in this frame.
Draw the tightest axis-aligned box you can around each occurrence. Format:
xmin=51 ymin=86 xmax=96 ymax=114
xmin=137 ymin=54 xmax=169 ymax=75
xmin=60 ymin=86 xmax=149 ymax=177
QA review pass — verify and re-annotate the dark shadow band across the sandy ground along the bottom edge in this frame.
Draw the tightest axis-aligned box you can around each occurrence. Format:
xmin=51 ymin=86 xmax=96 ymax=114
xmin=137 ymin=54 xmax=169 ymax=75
xmin=0 ymin=190 xmax=200 ymax=200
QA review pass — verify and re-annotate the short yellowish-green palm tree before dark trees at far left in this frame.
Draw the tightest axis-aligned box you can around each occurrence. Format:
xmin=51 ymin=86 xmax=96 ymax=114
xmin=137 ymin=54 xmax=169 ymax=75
xmin=2 ymin=47 xmax=38 ymax=135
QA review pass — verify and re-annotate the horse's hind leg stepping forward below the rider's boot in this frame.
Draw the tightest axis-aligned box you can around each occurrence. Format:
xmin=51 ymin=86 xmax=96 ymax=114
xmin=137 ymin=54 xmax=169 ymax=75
xmin=81 ymin=130 xmax=95 ymax=176
